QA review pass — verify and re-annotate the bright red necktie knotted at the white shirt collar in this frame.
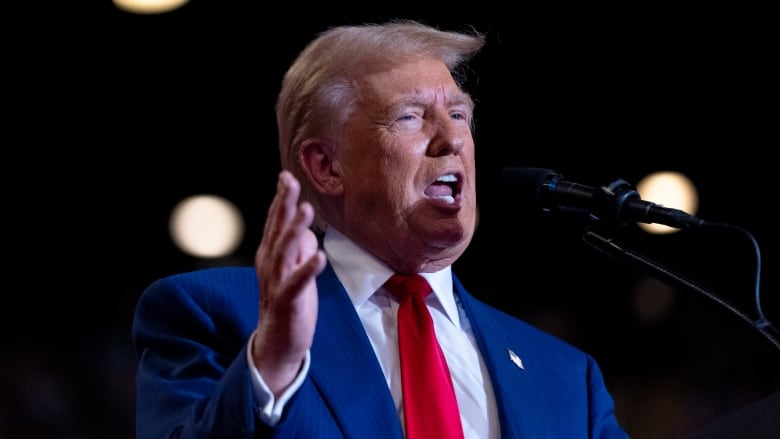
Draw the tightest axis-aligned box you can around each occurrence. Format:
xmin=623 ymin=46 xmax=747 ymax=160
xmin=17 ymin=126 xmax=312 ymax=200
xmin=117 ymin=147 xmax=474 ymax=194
xmin=385 ymin=274 xmax=463 ymax=439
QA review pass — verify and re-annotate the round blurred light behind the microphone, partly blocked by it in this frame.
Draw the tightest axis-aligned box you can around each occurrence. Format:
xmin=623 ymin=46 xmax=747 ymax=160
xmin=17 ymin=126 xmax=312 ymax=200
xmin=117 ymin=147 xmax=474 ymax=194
xmin=636 ymin=171 xmax=699 ymax=234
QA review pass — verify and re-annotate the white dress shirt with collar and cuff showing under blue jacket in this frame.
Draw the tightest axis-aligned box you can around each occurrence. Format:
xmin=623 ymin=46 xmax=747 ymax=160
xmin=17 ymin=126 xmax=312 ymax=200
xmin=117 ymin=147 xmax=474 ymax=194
xmin=247 ymin=227 xmax=500 ymax=439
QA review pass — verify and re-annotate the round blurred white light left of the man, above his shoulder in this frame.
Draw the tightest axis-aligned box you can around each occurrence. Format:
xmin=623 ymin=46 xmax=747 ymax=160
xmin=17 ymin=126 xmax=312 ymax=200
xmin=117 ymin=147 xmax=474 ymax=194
xmin=168 ymin=195 xmax=244 ymax=258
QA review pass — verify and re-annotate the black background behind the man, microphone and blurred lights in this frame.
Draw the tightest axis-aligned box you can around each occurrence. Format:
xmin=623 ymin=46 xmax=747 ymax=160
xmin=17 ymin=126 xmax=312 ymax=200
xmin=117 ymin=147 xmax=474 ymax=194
xmin=10 ymin=0 xmax=780 ymax=439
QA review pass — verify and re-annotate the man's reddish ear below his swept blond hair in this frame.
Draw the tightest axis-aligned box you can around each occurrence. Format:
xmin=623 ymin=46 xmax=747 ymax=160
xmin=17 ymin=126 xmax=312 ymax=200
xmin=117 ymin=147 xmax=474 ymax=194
xmin=298 ymin=138 xmax=343 ymax=196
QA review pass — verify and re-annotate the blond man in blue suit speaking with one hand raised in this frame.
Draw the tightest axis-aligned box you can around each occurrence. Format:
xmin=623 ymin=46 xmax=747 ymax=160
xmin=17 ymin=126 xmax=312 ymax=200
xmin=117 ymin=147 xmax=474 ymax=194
xmin=133 ymin=21 xmax=627 ymax=439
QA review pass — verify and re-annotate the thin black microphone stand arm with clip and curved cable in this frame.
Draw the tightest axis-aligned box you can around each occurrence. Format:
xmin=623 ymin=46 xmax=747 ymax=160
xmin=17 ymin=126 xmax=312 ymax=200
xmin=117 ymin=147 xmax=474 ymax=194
xmin=583 ymin=180 xmax=780 ymax=349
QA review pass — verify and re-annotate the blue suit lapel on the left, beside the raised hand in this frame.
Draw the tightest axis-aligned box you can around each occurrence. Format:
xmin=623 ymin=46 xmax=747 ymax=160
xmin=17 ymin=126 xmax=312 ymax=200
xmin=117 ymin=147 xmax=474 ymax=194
xmin=309 ymin=264 xmax=402 ymax=438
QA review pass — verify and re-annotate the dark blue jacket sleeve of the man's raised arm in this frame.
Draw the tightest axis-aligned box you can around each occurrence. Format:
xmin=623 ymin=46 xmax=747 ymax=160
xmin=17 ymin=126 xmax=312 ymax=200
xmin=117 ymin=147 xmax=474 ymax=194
xmin=132 ymin=276 xmax=259 ymax=439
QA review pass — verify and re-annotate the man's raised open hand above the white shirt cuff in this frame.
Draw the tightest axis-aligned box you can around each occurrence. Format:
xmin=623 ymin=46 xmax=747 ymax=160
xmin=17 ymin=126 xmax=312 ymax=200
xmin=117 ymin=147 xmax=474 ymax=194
xmin=252 ymin=170 xmax=326 ymax=396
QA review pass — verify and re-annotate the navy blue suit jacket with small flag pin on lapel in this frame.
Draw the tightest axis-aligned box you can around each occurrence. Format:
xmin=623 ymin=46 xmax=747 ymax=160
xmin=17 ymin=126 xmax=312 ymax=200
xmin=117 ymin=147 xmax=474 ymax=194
xmin=132 ymin=266 xmax=627 ymax=439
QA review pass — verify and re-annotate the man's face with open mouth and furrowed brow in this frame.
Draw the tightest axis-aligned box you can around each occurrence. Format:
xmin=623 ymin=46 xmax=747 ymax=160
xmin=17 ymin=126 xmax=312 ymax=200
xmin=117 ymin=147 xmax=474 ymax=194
xmin=336 ymin=59 xmax=476 ymax=271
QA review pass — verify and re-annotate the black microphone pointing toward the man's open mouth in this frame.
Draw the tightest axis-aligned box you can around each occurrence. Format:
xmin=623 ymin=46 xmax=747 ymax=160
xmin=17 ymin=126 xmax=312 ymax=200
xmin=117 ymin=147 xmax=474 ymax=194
xmin=499 ymin=168 xmax=705 ymax=229
